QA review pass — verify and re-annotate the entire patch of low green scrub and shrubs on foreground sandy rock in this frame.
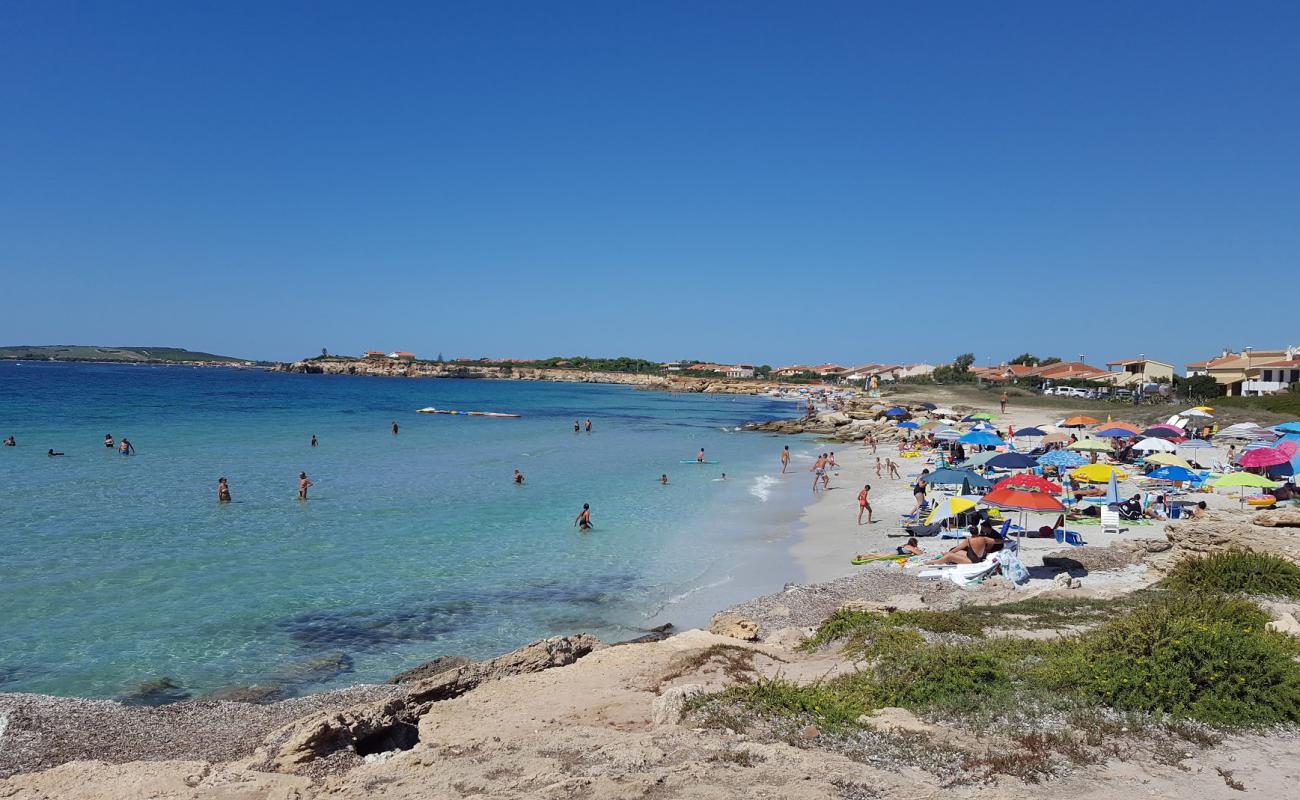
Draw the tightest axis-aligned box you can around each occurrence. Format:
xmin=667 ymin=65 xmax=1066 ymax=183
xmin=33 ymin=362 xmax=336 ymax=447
xmin=689 ymin=569 xmax=1300 ymax=780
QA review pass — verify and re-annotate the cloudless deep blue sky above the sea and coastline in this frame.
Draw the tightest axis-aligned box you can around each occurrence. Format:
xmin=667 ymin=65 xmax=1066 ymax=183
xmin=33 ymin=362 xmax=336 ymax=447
xmin=0 ymin=0 xmax=1300 ymax=364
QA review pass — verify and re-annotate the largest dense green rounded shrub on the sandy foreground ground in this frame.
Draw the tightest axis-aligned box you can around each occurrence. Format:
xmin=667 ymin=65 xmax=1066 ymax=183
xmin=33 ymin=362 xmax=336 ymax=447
xmin=1040 ymin=594 xmax=1300 ymax=727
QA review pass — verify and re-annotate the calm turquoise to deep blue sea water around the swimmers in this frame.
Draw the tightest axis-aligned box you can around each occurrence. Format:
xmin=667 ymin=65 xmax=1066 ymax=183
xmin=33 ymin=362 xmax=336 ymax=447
xmin=0 ymin=362 xmax=811 ymax=697
